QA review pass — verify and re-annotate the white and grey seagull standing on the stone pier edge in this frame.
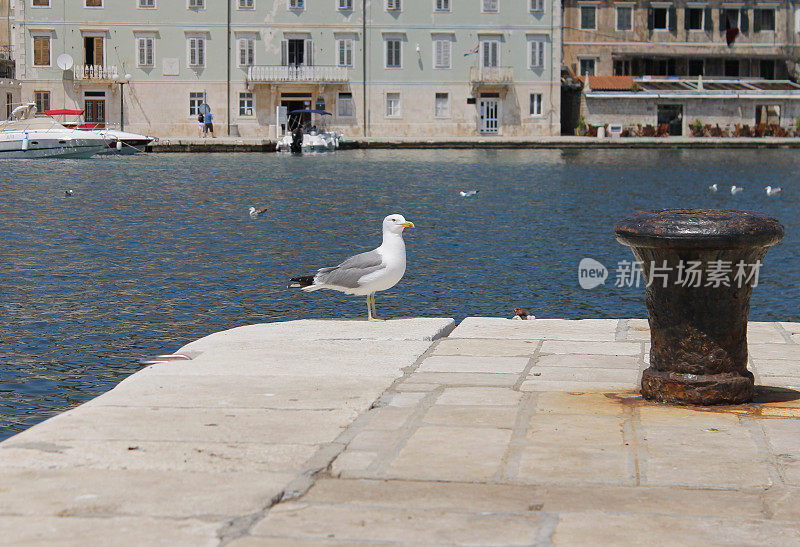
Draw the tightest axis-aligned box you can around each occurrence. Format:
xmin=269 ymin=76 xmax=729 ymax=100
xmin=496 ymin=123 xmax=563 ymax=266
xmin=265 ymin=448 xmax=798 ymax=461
xmin=289 ymin=214 xmax=414 ymax=321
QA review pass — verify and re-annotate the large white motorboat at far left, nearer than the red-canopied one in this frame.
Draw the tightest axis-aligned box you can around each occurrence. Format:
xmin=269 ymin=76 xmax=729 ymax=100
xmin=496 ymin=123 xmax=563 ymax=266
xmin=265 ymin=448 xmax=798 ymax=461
xmin=0 ymin=103 xmax=116 ymax=159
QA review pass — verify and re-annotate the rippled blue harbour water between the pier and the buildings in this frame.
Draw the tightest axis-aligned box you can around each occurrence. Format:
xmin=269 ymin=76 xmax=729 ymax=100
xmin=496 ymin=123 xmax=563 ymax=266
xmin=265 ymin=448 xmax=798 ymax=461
xmin=0 ymin=150 xmax=800 ymax=439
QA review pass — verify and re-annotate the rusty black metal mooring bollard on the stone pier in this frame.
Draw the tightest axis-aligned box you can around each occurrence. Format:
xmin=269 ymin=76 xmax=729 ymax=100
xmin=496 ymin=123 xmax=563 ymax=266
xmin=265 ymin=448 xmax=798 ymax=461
xmin=614 ymin=209 xmax=784 ymax=405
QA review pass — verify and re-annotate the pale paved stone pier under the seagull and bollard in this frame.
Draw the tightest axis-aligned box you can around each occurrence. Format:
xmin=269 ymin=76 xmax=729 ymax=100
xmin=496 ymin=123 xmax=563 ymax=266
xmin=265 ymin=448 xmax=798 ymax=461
xmin=0 ymin=318 xmax=800 ymax=547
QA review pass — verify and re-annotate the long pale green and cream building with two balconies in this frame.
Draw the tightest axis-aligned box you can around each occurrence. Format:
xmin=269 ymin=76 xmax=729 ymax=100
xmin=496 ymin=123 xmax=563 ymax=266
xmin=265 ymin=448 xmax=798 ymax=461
xmin=14 ymin=0 xmax=561 ymax=138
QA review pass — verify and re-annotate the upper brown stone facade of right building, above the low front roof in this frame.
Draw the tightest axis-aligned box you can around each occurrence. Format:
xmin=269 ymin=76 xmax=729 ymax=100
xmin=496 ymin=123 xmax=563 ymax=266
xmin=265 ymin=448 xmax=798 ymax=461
xmin=564 ymin=0 xmax=800 ymax=79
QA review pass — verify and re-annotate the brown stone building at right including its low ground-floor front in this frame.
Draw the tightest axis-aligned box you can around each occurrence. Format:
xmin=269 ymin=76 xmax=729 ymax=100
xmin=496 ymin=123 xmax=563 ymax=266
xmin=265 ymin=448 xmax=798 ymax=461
xmin=561 ymin=0 xmax=800 ymax=135
